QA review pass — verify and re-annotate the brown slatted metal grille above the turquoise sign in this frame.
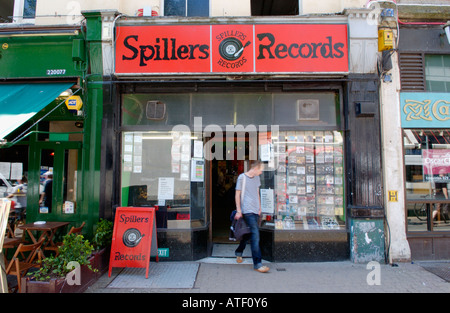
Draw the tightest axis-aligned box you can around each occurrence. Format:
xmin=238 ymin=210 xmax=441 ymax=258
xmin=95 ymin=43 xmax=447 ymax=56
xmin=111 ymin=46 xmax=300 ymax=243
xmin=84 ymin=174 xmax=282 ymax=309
xmin=399 ymin=53 xmax=425 ymax=91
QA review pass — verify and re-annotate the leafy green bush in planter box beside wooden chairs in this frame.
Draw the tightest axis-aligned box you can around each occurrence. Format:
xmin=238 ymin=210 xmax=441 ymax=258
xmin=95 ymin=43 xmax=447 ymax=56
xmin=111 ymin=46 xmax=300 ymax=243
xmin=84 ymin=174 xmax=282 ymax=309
xmin=22 ymin=234 xmax=97 ymax=293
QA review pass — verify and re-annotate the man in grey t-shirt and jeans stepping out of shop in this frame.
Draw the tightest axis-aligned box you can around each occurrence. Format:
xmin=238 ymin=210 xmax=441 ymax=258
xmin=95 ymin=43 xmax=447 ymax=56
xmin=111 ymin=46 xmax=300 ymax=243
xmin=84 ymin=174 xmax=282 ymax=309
xmin=234 ymin=161 xmax=269 ymax=273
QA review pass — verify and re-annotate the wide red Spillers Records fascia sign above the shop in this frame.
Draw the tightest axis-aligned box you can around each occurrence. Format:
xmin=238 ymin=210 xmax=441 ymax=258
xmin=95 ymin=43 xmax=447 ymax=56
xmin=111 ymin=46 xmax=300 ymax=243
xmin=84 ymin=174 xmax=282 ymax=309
xmin=115 ymin=24 xmax=348 ymax=75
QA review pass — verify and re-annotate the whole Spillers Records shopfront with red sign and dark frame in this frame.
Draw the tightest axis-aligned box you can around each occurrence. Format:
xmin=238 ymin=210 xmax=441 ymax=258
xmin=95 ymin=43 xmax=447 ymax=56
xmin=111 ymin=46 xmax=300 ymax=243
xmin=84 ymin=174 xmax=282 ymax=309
xmin=101 ymin=18 xmax=383 ymax=261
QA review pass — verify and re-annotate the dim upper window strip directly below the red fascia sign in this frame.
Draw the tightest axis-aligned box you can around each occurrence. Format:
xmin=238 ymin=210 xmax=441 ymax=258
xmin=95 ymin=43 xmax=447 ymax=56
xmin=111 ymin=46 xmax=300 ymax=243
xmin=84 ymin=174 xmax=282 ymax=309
xmin=122 ymin=92 xmax=340 ymax=128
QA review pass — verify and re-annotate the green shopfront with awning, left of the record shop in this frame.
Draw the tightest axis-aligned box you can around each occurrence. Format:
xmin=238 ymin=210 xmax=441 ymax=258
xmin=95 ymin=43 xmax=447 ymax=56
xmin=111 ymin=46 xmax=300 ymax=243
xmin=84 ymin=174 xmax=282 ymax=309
xmin=0 ymin=26 xmax=98 ymax=234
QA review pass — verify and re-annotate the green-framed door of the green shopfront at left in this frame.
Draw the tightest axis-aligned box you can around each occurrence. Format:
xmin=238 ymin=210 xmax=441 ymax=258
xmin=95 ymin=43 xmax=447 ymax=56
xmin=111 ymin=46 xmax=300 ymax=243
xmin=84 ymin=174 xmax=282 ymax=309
xmin=27 ymin=121 xmax=83 ymax=221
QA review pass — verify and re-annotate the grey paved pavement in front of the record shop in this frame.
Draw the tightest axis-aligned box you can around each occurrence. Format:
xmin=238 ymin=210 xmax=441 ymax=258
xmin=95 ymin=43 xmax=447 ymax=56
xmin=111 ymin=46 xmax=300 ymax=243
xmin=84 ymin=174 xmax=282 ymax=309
xmin=85 ymin=257 xmax=450 ymax=292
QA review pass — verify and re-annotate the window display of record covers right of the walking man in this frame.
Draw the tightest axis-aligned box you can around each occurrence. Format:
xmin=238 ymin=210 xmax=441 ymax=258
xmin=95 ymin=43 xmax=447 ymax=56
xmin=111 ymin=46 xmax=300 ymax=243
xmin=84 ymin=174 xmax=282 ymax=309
xmin=272 ymin=131 xmax=345 ymax=230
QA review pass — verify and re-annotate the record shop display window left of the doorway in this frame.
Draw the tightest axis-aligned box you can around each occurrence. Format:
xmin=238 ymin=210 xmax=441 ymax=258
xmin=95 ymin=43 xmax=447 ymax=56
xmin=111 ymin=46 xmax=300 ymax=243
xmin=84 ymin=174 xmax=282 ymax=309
xmin=121 ymin=131 xmax=205 ymax=228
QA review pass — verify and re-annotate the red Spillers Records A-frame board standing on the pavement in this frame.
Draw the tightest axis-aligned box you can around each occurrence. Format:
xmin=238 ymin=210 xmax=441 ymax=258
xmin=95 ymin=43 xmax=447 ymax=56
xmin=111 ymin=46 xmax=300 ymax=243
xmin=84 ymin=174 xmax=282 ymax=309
xmin=108 ymin=207 xmax=158 ymax=278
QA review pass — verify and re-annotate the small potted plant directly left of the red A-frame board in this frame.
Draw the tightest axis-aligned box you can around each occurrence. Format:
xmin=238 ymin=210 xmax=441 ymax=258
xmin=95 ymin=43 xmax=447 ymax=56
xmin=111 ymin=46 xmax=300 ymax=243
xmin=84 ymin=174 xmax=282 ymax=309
xmin=92 ymin=219 xmax=114 ymax=276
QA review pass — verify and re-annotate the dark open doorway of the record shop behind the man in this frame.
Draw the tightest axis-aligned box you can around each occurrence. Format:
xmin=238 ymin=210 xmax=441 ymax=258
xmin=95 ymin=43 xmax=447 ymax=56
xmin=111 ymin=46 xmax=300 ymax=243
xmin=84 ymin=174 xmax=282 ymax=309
xmin=210 ymin=136 xmax=251 ymax=243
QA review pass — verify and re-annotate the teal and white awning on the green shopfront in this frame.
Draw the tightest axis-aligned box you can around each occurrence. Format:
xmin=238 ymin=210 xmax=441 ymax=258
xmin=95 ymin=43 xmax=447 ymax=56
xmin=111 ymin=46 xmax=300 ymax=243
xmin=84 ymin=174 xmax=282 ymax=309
xmin=0 ymin=83 xmax=73 ymax=140
